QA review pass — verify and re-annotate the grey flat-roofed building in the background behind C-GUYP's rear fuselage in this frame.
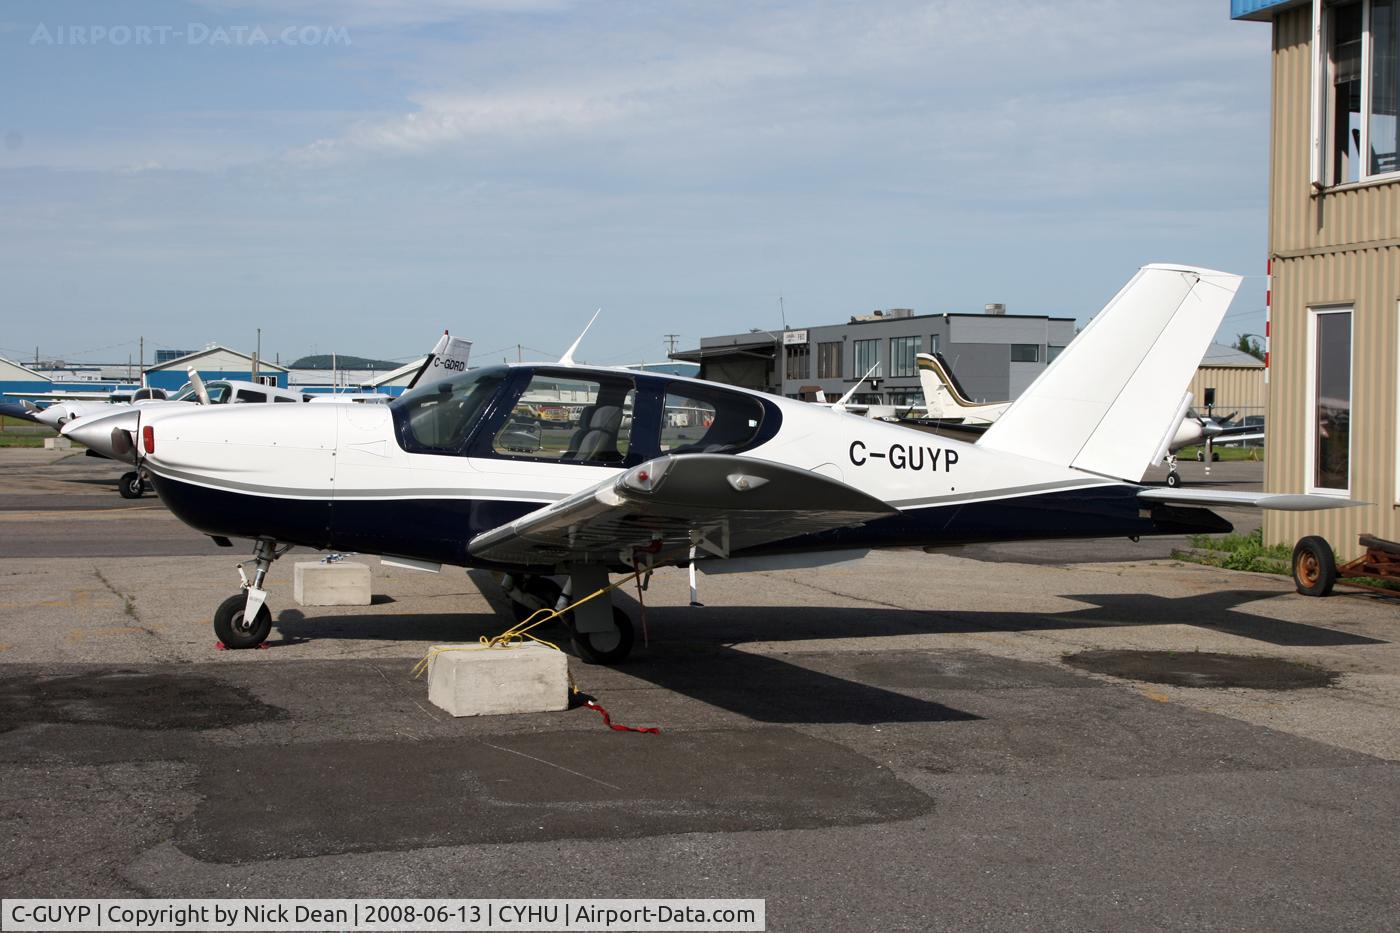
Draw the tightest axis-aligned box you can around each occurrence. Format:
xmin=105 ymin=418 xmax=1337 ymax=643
xmin=672 ymin=305 xmax=1075 ymax=405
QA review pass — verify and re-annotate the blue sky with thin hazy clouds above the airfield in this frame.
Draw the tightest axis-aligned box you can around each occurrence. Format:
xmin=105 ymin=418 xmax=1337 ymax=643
xmin=0 ymin=0 xmax=1270 ymax=363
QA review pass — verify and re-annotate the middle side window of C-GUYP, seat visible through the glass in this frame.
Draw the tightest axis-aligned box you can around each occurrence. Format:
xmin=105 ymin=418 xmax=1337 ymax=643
xmin=491 ymin=373 xmax=637 ymax=465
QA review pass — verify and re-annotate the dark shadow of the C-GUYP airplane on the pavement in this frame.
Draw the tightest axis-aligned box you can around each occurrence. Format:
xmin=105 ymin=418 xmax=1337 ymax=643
xmin=270 ymin=590 xmax=1385 ymax=724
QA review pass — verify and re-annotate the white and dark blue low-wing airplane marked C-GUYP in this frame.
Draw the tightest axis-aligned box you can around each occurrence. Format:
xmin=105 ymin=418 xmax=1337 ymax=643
xmin=139 ymin=265 xmax=1345 ymax=663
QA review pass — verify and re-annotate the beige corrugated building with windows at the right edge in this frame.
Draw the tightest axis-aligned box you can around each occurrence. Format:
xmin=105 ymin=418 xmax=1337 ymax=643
xmin=1231 ymin=0 xmax=1400 ymax=551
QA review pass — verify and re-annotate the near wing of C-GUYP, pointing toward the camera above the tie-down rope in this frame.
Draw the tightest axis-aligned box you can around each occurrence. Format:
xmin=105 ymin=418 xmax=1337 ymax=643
xmin=468 ymin=454 xmax=896 ymax=566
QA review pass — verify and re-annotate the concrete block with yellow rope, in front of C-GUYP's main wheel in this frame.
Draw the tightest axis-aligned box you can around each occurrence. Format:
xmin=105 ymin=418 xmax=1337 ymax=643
xmin=428 ymin=642 xmax=568 ymax=716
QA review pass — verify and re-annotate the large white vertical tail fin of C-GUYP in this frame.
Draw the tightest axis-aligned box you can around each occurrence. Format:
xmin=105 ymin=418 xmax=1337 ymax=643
xmin=979 ymin=265 xmax=1240 ymax=481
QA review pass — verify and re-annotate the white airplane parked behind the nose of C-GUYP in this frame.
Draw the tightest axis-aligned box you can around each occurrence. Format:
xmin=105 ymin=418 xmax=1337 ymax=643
xmin=60 ymin=331 xmax=472 ymax=499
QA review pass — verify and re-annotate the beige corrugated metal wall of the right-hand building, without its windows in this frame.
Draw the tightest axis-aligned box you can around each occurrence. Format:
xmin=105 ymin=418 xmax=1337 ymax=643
xmin=1264 ymin=7 xmax=1400 ymax=560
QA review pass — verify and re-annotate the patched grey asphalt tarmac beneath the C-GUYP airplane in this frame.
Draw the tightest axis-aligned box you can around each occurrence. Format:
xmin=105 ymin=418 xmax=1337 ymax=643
xmin=0 ymin=450 xmax=1400 ymax=930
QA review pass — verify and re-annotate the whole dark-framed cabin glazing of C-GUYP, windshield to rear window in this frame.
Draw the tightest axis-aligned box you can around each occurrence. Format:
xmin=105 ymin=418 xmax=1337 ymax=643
xmin=389 ymin=366 xmax=781 ymax=467
